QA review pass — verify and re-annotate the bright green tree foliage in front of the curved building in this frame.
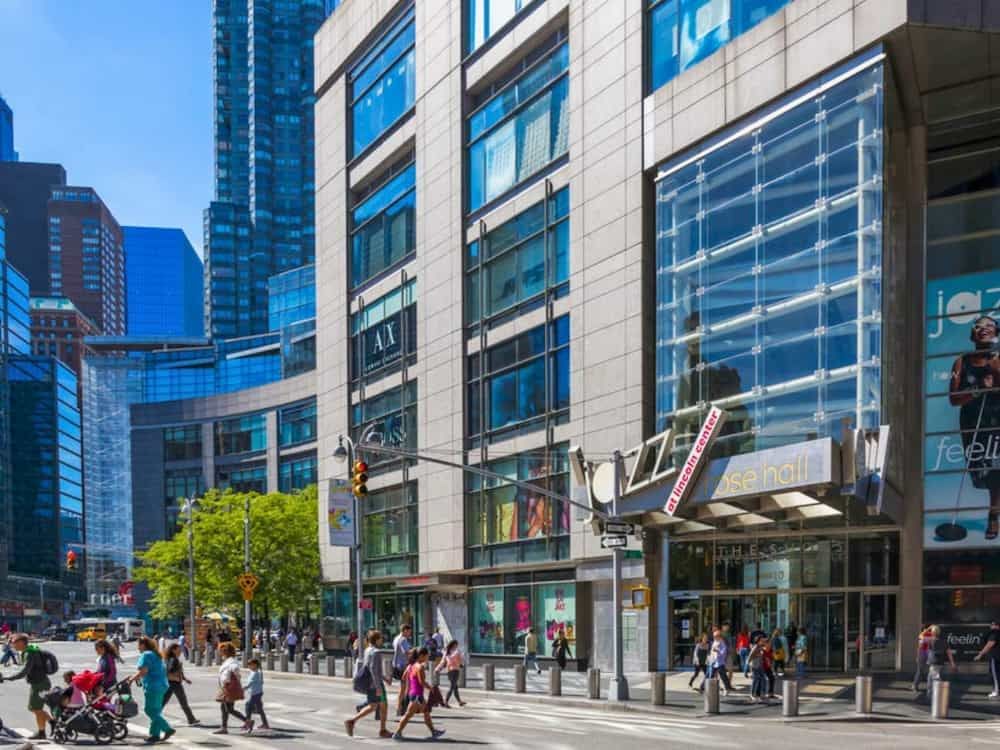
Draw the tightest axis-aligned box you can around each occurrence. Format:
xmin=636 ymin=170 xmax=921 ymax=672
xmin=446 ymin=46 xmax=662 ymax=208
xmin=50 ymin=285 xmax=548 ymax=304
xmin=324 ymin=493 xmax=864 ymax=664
xmin=135 ymin=487 xmax=320 ymax=618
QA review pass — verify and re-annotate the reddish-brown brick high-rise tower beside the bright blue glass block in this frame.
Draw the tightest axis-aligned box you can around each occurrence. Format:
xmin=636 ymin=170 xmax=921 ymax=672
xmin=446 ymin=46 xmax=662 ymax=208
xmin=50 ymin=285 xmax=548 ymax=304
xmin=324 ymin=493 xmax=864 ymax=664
xmin=48 ymin=185 xmax=127 ymax=336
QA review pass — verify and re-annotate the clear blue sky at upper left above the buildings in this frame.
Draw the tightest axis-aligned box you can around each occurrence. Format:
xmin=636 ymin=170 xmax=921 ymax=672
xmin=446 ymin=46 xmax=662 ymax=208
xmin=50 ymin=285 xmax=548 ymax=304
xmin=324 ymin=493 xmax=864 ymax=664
xmin=0 ymin=0 xmax=213 ymax=251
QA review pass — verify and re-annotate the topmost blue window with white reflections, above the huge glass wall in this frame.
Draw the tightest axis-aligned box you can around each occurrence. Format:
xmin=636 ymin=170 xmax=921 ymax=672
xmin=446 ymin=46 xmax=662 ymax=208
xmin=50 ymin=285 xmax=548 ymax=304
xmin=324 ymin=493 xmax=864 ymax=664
xmin=646 ymin=0 xmax=791 ymax=90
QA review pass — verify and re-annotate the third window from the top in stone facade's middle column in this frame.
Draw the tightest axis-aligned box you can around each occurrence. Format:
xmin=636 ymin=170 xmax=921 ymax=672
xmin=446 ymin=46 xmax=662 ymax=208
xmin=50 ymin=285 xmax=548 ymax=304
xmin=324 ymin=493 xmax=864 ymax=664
xmin=465 ymin=187 xmax=569 ymax=324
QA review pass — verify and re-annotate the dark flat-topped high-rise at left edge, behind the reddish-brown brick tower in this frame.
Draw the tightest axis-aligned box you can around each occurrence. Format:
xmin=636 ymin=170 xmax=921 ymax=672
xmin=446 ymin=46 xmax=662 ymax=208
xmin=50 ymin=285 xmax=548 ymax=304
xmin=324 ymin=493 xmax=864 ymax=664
xmin=0 ymin=160 xmax=66 ymax=297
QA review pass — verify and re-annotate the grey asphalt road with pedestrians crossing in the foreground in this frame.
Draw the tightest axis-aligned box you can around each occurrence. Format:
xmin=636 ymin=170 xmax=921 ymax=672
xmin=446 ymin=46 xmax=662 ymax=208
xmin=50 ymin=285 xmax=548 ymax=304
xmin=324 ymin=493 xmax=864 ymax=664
xmin=0 ymin=643 xmax=1000 ymax=750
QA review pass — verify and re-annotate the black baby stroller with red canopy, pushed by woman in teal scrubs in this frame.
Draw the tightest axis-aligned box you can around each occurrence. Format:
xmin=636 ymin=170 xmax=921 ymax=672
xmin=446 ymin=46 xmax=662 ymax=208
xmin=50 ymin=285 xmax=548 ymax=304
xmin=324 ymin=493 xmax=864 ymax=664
xmin=46 ymin=671 xmax=138 ymax=745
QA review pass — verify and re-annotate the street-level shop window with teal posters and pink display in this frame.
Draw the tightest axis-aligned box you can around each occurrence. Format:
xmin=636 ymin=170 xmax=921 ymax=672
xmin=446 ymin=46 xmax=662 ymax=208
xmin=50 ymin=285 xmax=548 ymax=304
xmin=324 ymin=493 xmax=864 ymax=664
xmin=469 ymin=580 xmax=576 ymax=656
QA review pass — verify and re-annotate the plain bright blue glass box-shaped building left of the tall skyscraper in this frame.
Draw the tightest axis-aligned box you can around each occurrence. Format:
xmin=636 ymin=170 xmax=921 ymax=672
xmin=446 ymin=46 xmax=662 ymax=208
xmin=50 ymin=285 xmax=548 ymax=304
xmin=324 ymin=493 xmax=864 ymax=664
xmin=122 ymin=227 xmax=205 ymax=336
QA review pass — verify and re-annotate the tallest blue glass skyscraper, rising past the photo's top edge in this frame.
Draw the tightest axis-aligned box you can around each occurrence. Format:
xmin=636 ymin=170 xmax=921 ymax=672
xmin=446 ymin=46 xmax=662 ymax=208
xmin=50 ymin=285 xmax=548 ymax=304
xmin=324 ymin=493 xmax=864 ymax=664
xmin=204 ymin=0 xmax=336 ymax=338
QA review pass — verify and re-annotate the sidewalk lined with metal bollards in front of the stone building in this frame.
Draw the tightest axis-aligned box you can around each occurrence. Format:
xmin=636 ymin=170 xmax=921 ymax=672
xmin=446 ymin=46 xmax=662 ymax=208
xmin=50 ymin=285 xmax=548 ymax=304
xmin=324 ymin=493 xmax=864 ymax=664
xmin=190 ymin=657 xmax=1000 ymax=722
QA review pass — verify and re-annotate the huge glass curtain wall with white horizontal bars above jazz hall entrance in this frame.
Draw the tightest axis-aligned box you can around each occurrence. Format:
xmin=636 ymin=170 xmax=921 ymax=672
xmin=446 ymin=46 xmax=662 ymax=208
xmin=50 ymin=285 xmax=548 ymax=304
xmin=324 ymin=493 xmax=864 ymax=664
xmin=656 ymin=58 xmax=883 ymax=462
